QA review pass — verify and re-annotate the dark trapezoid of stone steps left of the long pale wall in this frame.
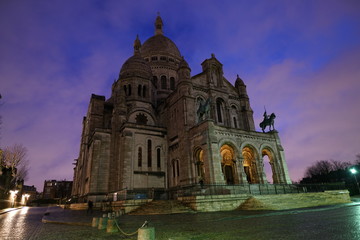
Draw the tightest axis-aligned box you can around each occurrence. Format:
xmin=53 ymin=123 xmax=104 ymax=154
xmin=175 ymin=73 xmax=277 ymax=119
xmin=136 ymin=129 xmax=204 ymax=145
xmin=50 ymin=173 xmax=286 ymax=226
xmin=128 ymin=200 xmax=195 ymax=215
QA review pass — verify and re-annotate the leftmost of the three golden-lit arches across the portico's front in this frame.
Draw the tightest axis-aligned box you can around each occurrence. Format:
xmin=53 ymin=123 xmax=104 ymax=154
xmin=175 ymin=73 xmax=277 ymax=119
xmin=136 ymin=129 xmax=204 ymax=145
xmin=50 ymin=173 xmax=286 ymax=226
xmin=220 ymin=144 xmax=235 ymax=184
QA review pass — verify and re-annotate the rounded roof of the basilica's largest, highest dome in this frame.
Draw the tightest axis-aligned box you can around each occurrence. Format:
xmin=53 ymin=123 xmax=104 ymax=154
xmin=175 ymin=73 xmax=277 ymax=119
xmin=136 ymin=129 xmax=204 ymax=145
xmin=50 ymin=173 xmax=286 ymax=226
xmin=141 ymin=34 xmax=181 ymax=58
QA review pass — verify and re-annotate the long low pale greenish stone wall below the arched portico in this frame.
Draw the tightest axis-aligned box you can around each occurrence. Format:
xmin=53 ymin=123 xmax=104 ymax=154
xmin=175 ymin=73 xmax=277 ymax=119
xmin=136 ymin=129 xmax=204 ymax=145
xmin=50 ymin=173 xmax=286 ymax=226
xmin=178 ymin=190 xmax=351 ymax=212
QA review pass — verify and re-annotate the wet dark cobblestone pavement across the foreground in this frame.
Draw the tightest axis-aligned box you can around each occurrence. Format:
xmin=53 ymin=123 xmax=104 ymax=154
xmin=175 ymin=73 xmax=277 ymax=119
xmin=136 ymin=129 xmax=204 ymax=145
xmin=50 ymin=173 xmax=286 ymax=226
xmin=0 ymin=197 xmax=360 ymax=240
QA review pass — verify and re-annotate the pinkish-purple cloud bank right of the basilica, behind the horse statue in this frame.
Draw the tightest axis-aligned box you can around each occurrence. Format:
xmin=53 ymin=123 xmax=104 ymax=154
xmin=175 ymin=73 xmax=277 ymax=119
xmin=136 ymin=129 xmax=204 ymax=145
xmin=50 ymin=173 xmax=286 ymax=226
xmin=248 ymin=47 xmax=360 ymax=180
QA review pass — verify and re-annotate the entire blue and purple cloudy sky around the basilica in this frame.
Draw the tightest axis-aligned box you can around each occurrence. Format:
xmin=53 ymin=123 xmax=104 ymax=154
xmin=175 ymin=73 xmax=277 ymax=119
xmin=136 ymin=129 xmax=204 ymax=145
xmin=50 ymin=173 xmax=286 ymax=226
xmin=0 ymin=0 xmax=360 ymax=191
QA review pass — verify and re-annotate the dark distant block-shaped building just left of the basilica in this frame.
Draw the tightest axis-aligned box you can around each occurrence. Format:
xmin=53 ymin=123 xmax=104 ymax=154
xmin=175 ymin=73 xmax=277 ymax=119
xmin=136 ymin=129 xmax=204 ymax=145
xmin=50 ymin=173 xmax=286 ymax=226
xmin=43 ymin=180 xmax=73 ymax=199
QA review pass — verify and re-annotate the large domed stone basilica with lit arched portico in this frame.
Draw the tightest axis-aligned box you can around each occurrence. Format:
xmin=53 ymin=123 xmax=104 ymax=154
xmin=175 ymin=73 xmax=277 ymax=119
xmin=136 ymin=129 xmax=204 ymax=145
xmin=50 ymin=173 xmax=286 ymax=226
xmin=72 ymin=16 xmax=291 ymax=201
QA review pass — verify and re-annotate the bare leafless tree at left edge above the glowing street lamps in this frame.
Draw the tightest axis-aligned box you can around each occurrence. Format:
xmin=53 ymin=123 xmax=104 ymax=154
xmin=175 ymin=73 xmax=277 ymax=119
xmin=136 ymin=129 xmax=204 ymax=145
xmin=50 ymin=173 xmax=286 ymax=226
xmin=2 ymin=144 xmax=29 ymax=180
